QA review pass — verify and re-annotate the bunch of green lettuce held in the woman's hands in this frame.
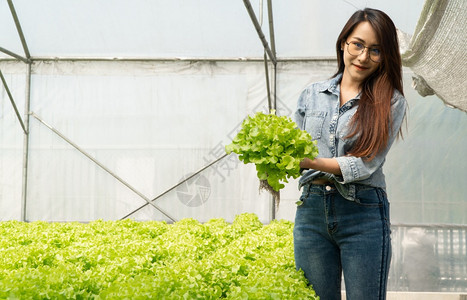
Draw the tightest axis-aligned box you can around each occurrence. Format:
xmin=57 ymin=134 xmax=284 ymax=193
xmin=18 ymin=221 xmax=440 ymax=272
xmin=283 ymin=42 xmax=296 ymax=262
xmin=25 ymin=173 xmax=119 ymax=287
xmin=225 ymin=112 xmax=318 ymax=192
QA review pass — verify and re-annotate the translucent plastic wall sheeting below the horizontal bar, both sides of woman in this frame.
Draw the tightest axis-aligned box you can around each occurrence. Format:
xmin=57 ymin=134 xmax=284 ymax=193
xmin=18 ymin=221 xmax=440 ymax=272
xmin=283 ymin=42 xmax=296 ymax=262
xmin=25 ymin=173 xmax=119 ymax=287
xmin=2 ymin=57 xmax=467 ymax=224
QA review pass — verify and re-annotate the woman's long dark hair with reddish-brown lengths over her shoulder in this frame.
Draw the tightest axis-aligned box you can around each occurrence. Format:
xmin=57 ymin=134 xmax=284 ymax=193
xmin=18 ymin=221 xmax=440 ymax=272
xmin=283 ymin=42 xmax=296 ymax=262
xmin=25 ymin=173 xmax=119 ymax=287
xmin=335 ymin=8 xmax=403 ymax=160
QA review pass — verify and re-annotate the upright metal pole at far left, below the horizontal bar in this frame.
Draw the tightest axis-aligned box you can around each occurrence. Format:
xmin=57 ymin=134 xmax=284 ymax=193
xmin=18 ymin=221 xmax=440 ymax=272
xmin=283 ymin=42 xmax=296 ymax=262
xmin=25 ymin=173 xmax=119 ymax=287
xmin=21 ymin=64 xmax=31 ymax=222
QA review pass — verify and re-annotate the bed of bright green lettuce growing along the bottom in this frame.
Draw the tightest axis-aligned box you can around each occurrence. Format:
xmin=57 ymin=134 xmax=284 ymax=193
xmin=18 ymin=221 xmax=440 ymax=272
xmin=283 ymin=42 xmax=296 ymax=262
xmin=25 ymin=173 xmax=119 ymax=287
xmin=0 ymin=214 xmax=318 ymax=299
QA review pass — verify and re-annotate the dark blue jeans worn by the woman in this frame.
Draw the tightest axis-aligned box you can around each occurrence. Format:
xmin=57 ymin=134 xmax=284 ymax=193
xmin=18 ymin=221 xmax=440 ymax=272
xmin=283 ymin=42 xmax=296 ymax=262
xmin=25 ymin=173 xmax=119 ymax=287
xmin=293 ymin=184 xmax=391 ymax=300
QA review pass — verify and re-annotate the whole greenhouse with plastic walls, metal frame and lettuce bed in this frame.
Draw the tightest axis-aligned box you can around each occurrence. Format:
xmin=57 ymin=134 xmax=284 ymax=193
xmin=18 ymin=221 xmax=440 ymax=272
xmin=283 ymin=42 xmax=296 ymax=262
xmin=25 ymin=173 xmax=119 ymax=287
xmin=0 ymin=0 xmax=467 ymax=300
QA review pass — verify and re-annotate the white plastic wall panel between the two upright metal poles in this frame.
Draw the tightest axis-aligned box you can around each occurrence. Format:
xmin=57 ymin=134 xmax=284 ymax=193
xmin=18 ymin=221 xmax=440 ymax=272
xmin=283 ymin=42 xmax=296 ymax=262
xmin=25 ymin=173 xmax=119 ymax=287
xmin=1 ymin=62 xmax=269 ymax=221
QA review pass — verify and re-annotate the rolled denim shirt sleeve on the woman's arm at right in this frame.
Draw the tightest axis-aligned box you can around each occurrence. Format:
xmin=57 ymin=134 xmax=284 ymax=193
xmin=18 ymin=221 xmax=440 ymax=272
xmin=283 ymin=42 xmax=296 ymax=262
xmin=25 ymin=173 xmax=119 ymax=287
xmin=333 ymin=91 xmax=407 ymax=184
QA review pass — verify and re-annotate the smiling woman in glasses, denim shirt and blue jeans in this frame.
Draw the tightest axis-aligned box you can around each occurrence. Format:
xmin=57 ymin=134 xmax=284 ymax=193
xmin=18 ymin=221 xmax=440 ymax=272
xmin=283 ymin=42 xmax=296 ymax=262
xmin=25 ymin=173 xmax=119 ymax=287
xmin=294 ymin=8 xmax=407 ymax=300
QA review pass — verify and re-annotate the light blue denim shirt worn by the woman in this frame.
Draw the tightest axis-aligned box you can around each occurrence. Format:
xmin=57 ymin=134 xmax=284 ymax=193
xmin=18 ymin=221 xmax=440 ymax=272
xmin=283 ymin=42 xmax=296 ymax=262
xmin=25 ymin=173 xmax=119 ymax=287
xmin=295 ymin=74 xmax=407 ymax=201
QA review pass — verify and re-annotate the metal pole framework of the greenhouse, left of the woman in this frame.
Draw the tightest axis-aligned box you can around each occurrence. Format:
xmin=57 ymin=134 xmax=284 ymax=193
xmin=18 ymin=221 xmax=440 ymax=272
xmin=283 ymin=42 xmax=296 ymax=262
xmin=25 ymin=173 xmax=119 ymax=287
xmin=0 ymin=0 xmax=335 ymax=221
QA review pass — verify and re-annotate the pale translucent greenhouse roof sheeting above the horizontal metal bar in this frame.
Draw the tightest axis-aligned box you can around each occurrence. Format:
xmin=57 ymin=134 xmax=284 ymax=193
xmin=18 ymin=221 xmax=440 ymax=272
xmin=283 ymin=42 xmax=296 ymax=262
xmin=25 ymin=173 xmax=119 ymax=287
xmin=0 ymin=0 xmax=423 ymax=59
